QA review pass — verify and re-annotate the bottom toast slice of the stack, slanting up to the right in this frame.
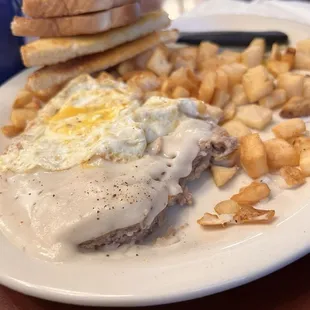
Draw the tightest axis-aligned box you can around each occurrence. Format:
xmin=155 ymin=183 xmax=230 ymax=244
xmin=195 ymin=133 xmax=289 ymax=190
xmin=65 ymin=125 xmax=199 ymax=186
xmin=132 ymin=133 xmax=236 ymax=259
xmin=27 ymin=30 xmax=178 ymax=93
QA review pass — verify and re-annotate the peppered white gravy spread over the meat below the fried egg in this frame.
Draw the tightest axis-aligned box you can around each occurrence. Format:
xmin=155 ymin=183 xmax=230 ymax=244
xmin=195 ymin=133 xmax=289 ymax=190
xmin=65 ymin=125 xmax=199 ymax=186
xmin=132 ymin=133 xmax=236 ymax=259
xmin=0 ymin=119 xmax=215 ymax=261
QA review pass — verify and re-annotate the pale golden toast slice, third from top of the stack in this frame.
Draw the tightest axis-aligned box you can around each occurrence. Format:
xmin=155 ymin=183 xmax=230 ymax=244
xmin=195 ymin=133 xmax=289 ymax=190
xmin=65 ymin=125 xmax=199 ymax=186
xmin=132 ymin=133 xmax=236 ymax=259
xmin=21 ymin=11 xmax=170 ymax=67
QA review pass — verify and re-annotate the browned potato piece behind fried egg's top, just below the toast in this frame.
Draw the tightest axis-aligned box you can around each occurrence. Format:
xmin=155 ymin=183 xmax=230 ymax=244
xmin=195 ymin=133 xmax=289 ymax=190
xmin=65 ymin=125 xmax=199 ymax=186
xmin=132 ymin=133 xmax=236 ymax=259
xmin=127 ymin=71 xmax=161 ymax=92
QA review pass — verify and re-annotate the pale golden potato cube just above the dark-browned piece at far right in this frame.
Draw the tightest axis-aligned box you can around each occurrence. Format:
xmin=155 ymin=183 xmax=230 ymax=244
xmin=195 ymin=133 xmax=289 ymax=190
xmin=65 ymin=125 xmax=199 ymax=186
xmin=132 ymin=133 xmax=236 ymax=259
xmin=277 ymin=73 xmax=304 ymax=98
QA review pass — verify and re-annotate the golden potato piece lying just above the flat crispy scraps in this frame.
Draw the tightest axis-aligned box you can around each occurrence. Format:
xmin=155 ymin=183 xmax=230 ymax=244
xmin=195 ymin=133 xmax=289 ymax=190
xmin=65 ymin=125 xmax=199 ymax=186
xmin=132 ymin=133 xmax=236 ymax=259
xmin=230 ymin=182 xmax=270 ymax=206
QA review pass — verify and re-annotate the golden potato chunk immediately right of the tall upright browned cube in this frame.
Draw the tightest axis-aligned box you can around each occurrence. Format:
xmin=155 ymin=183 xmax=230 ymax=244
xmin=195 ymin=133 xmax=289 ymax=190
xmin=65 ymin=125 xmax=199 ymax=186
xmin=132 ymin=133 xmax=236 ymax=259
xmin=265 ymin=138 xmax=299 ymax=170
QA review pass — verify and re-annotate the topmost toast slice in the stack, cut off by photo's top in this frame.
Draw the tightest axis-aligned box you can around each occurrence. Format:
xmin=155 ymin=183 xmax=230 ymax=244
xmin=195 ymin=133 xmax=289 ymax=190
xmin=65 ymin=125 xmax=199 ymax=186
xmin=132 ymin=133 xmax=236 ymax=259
xmin=23 ymin=0 xmax=161 ymax=18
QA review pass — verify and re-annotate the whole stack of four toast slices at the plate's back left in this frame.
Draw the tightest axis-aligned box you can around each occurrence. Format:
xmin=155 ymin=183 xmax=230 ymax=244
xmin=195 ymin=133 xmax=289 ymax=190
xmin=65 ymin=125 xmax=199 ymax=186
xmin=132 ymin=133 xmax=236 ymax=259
xmin=11 ymin=0 xmax=178 ymax=95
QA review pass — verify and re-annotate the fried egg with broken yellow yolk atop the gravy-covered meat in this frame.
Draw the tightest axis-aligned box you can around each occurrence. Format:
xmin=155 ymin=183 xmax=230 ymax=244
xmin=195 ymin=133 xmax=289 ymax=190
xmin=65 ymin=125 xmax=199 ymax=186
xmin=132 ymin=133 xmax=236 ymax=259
xmin=0 ymin=75 xmax=218 ymax=172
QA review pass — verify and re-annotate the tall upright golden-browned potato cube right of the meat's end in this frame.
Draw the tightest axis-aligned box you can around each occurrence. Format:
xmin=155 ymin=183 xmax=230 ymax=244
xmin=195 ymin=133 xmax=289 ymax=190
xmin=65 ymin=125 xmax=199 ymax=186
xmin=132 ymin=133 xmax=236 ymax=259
xmin=240 ymin=134 xmax=269 ymax=179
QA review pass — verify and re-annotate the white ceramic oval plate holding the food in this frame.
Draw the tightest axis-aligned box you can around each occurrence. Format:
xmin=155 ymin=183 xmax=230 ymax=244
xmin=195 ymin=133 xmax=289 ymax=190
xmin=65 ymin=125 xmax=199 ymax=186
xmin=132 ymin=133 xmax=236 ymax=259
xmin=0 ymin=16 xmax=310 ymax=306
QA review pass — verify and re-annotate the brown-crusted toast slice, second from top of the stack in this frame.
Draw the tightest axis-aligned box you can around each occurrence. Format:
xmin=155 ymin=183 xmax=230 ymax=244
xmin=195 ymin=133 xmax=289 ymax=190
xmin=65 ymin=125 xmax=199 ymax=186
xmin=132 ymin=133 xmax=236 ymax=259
xmin=11 ymin=3 xmax=142 ymax=37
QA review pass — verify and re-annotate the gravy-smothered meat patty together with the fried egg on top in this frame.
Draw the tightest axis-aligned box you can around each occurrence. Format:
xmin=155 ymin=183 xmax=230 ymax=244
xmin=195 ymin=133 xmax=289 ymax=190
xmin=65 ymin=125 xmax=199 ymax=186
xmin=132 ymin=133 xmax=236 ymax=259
xmin=0 ymin=75 xmax=237 ymax=259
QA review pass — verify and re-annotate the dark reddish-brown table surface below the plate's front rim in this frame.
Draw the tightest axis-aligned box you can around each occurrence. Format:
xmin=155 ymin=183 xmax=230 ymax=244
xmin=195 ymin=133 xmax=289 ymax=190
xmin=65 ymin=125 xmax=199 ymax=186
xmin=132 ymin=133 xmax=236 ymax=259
xmin=0 ymin=255 xmax=310 ymax=310
